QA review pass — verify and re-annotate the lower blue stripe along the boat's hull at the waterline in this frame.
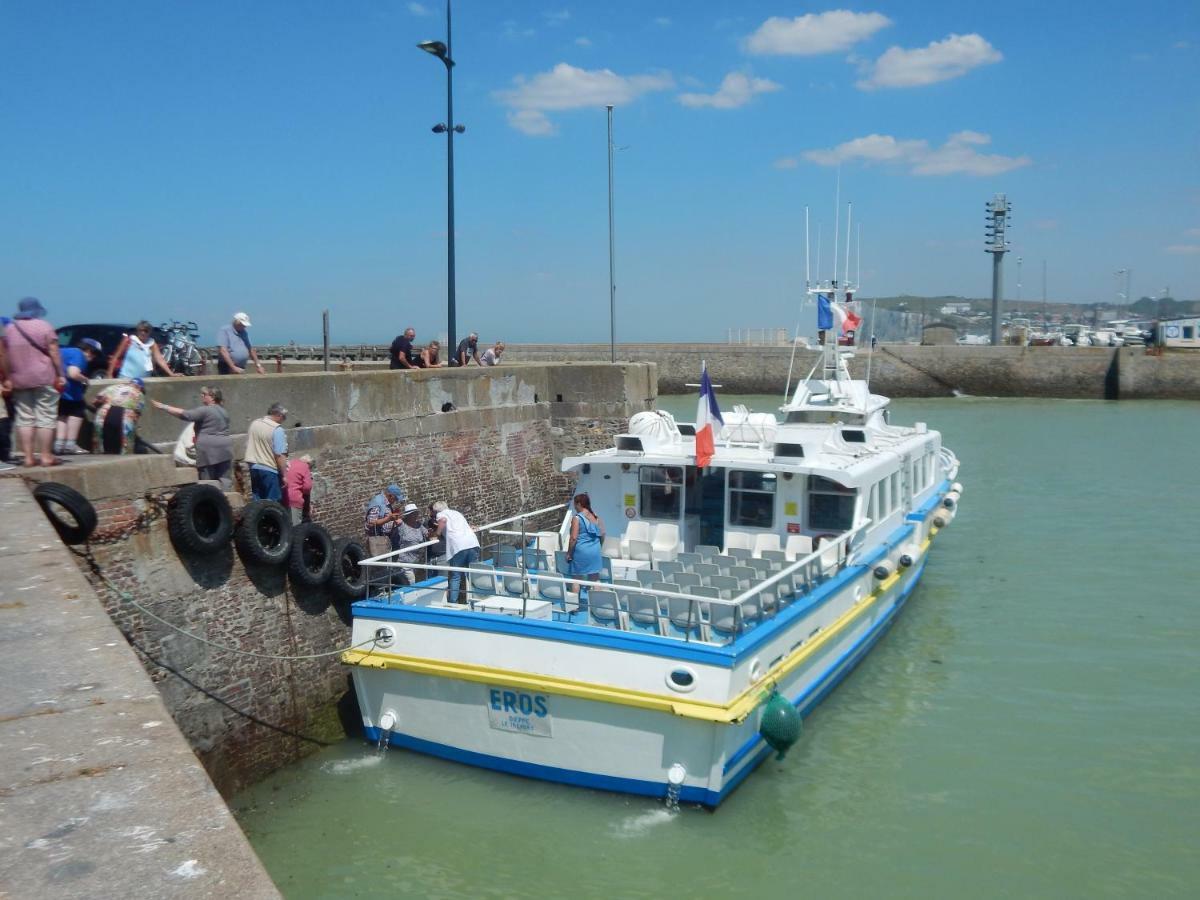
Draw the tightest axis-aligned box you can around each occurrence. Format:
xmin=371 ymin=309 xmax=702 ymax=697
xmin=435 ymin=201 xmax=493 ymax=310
xmin=366 ymin=563 xmax=924 ymax=806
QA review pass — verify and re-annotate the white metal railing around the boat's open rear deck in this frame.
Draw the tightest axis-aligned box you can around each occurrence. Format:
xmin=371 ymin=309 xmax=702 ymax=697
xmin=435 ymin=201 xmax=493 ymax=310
xmin=362 ymin=506 xmax=870 ymax=644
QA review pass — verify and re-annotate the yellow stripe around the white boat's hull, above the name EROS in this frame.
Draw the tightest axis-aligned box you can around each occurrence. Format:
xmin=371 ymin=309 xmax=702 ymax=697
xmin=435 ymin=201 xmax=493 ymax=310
xmin=342 ymin=538 xmax=930 ymax=724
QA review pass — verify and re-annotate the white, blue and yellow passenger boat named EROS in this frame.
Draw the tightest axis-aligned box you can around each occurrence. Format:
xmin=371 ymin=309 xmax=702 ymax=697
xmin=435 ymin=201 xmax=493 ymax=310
xmin=343 ymin=286 xmax=962 ymax=806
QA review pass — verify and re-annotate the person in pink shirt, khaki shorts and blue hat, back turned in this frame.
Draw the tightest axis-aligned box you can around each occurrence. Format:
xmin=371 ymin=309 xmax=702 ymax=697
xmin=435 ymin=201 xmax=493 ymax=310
xmin=2 ymin=296 xmax=66 ymax=468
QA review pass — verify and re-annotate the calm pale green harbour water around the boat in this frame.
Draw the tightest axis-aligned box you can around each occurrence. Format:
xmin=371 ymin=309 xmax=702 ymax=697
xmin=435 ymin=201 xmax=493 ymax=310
xmin=235 ymin=397 xmax=1200 ymax=899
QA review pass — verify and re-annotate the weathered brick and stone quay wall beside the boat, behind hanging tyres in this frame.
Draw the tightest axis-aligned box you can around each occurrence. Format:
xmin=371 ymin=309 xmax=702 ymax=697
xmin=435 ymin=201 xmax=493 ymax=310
xmin=47 ymin=364 xmax=656 ymax=796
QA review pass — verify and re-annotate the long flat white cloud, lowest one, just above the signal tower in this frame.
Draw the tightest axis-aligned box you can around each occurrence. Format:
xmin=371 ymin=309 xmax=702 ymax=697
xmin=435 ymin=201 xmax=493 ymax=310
xmin=806 ymin=131 xmax=1033 ymax=175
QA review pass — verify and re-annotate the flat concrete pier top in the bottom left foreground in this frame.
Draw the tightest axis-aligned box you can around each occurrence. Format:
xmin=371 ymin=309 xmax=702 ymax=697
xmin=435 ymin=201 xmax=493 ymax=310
xmin=0 ymin=478 xmax=278 ymax=899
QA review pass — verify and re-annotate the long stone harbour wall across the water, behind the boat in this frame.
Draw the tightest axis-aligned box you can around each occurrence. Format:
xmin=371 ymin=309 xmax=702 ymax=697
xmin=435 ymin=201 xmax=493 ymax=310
xmin=504 ymin=343 xmax=1200 ymax=400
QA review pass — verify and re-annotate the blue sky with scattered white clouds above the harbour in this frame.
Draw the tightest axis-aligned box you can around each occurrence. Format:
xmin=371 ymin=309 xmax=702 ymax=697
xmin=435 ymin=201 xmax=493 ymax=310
xmin=0 ymin=0 xmax=1200 ymax=343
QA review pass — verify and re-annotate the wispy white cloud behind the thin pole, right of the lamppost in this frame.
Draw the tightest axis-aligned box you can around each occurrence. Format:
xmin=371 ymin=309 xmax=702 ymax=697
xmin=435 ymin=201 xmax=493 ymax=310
xmin=494 ymin=62 xmax=674 ymax=137
